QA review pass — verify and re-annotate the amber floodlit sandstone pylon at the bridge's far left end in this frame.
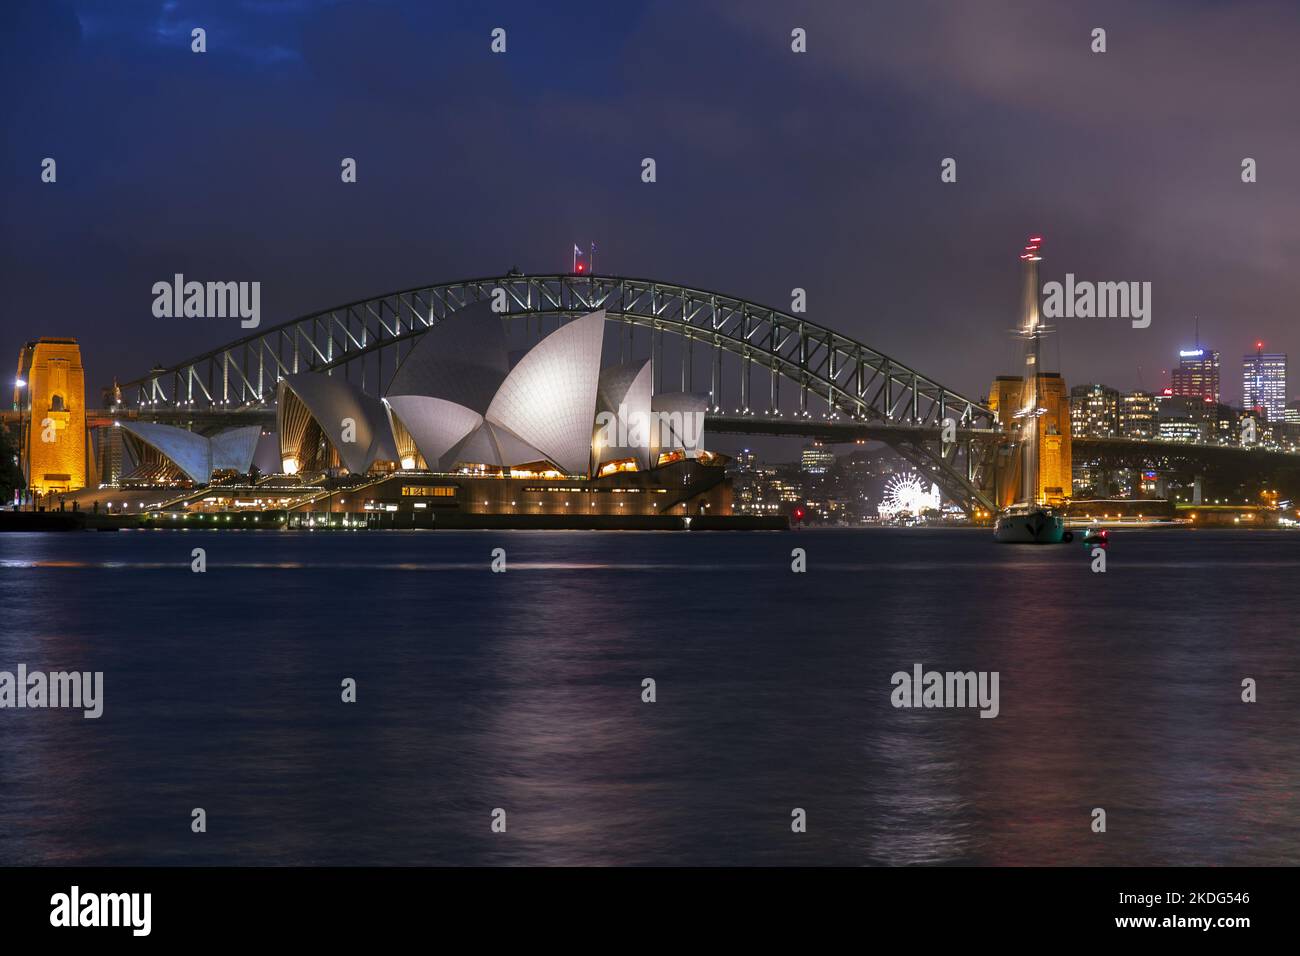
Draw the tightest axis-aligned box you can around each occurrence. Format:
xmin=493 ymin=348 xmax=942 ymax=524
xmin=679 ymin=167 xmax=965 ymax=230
xmin=13 ymin=338 xmax=86 ymax=494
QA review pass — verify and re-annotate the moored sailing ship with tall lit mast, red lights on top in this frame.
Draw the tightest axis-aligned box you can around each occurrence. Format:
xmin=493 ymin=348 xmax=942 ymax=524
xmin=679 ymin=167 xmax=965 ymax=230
xmin=993 ymin=237 xmax=1069 ymax=545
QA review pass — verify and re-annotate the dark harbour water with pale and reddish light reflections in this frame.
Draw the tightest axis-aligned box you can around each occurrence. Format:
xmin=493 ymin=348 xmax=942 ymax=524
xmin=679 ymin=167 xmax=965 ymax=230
xmin=0 ymin=531 xmax=1300 ymax=865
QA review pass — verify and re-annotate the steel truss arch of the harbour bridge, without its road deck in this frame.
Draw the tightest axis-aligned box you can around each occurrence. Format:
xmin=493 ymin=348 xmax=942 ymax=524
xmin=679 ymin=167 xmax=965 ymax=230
xmin=120 ymin=273 xmax=997 ymax=507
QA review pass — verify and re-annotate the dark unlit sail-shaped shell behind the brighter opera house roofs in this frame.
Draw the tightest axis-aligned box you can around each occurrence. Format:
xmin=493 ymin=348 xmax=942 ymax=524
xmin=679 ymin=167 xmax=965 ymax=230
xmin=385 ymin=300 xmax=510 ymax=416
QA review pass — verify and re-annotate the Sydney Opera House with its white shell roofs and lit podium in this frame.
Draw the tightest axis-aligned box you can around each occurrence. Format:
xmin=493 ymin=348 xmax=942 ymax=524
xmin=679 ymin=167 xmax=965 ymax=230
xmin=111 ymin=303 xmax=731 ymax=525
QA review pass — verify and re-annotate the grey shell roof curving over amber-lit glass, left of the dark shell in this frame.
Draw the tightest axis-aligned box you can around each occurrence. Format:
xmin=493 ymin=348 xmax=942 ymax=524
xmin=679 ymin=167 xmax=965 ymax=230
xmin=277 ymin=372 xmax=398 ymax=475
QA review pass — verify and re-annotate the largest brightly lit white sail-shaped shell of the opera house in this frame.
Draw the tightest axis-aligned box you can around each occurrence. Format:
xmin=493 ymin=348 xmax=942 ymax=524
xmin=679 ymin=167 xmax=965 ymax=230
xmin=486 ymin=310 xmax=605 ymax=475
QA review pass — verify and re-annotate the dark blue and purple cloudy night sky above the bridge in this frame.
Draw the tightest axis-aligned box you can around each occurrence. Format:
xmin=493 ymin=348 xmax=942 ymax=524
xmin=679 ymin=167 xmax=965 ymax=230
xmin=0 ymin=0 xmax=1300 ymax=402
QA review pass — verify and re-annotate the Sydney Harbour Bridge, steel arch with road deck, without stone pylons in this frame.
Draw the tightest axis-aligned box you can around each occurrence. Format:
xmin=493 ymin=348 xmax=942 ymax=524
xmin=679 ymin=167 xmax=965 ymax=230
xmin=83 ymin=271 xmax=1295 ymax=512
